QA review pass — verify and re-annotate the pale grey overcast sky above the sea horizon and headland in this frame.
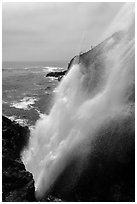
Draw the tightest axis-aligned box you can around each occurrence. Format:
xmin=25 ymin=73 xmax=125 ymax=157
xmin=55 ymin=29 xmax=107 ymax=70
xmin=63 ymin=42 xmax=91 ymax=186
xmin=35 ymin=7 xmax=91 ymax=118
xmin=2 ymin=3 xmax=123 ymax=61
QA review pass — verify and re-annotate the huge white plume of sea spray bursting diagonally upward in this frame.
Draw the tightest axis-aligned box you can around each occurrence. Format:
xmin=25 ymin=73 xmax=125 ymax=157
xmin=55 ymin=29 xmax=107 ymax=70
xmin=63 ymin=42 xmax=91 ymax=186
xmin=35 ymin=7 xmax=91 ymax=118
xmin=23 ymin=4 xmax=134 ymax=198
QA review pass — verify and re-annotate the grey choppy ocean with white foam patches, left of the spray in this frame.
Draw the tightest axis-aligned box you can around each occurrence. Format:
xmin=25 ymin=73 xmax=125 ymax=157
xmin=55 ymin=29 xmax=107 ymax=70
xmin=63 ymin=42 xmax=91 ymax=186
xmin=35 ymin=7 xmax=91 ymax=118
xmin=2 ymin=62 xmax=67 ymax=126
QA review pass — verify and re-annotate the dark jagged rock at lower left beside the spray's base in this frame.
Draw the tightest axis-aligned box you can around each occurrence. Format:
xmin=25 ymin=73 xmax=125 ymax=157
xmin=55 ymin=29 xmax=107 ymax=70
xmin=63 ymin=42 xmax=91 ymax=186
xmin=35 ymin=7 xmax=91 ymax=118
xmin=2 ymin=116 xmax=35 ymax=202
